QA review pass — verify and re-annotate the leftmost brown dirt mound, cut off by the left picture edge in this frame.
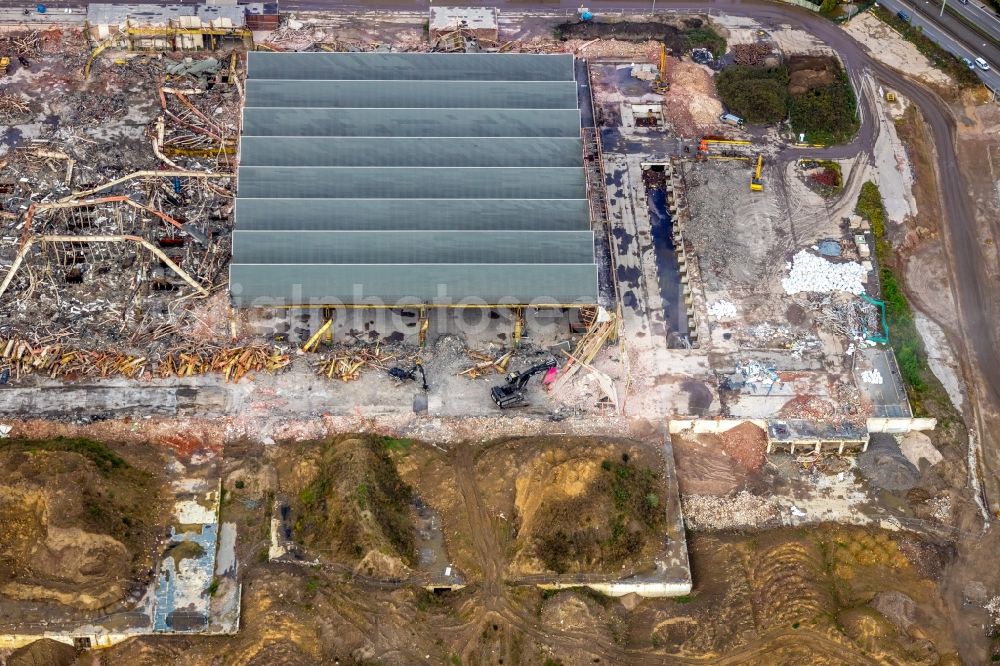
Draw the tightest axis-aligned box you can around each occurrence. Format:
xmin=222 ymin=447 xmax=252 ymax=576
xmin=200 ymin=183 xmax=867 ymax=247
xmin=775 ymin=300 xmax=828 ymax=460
xmin=0 ymin=439 xmax=163 ymax=609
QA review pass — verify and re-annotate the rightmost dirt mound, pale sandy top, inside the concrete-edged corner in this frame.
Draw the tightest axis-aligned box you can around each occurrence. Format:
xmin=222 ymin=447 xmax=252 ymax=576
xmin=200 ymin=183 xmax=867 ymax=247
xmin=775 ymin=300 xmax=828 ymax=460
xmin=476 ymin=438 xmax=666 ymax=574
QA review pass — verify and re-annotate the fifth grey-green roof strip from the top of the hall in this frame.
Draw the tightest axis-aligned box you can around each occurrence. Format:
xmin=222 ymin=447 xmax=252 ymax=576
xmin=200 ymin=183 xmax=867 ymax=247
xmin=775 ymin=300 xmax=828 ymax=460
xmin=239 ymin=166 xmax=587 ymax=199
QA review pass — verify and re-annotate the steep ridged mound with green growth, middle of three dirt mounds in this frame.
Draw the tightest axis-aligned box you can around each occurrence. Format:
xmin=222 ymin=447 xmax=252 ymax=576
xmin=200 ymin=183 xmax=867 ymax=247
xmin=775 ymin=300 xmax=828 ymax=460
xmin=277 ymin=436 xmax=414 ymax=571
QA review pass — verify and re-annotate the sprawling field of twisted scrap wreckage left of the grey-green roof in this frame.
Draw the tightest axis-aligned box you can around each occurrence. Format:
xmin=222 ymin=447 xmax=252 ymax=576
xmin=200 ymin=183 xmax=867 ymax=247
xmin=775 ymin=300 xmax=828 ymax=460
xmin=0 ymin=31 xmax=242 ymax=352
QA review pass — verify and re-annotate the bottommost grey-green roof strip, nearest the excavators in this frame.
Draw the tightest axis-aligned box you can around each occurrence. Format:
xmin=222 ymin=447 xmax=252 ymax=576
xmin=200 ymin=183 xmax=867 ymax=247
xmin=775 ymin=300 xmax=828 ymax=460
xmin=229 ymin=263 xmax=597 ymax=307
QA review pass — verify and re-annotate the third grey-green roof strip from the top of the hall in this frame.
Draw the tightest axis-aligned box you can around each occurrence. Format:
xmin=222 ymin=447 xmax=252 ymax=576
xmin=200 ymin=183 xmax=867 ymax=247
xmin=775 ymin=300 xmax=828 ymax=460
xmin=243 ymin=107 xmax=580 ymax=137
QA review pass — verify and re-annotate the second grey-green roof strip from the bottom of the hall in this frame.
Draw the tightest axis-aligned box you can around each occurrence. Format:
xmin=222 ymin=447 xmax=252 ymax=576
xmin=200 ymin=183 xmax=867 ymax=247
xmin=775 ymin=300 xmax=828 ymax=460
xmin=233 ymin=230 xmax=594 ymax=264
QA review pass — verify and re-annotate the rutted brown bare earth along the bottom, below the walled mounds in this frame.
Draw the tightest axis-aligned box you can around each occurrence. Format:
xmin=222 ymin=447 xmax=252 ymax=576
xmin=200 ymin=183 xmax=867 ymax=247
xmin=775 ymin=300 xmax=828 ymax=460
xmin=64 ymin=527 xmax=959 ymax=665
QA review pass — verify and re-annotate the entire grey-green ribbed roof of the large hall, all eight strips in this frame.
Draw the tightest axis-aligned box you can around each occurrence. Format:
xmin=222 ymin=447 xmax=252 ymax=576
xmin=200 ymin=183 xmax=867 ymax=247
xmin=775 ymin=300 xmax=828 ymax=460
xmin=230 ymin=52 xmax=597 ymax=307
